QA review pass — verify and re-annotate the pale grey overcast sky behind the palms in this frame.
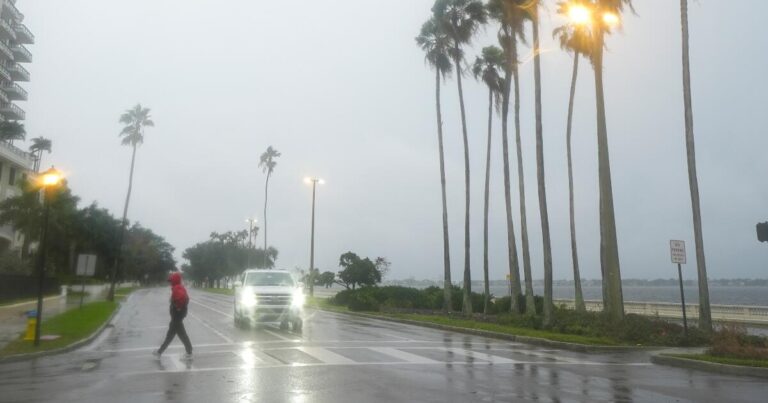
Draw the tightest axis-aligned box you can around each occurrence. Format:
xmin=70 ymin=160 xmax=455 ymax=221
xmin=18 ymin=0 xmax=768 ymax=280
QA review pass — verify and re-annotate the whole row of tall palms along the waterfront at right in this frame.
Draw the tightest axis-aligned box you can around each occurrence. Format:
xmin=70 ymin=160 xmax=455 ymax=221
xmin=416 ymin=0 xmax=711 ymax=329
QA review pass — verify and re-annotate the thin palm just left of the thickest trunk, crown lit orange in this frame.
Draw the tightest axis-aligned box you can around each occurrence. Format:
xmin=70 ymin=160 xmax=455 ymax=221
xmin=553 ymin=0 xmax=592 ymax=312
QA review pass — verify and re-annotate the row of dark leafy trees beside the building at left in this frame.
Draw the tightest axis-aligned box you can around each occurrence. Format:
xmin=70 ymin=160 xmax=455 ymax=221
xmin=0 ymin=177 xmax=176 ymax=284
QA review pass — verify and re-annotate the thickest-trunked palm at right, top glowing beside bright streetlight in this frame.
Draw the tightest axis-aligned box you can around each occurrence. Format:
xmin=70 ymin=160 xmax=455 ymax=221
xmin=590 ymin=0 xmax=632 ymax=321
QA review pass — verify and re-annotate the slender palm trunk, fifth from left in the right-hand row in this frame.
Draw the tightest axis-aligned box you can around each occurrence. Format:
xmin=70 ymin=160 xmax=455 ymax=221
xmin=510 ymin=38 xmax=536 ymax=315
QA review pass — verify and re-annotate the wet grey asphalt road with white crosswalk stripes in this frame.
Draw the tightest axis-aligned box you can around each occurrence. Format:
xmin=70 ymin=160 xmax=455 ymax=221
xmin=0 ymin=289 xmax=768 ymax=403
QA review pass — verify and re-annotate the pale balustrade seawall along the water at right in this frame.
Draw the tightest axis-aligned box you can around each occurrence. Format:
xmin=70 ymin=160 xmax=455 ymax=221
xmin=554 ymin=299 xmax=768 ymax=325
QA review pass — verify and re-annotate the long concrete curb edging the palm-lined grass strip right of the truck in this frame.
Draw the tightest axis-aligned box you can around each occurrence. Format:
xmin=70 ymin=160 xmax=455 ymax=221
xmin=316 ymin=307 xmax=665 ymax=353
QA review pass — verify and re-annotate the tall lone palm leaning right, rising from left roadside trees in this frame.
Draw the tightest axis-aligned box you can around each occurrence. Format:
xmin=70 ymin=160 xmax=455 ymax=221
xmin=107 ymin=104 xmax=155 ymax=301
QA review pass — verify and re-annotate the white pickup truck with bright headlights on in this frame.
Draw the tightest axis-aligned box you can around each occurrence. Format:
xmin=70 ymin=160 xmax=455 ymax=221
xmin=234 ymin=270 xmax=305 ymax=332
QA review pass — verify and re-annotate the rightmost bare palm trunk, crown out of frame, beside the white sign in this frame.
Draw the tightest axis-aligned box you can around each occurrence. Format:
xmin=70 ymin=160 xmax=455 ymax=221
xmin=680 ymin=0 xmax=712 ymax=331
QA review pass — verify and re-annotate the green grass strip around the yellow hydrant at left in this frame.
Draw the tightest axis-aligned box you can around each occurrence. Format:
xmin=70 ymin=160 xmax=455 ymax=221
xmin=0 ymin=301 xmax=118 ymax=357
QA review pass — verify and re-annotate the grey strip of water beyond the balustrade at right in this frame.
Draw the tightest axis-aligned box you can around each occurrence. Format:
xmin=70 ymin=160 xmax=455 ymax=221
xmin=488 ymin=286 xmax=768 ymax=306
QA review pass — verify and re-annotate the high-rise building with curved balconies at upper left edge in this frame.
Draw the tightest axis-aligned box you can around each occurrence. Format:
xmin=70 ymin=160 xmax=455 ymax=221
xmin=0 ymin=0 xmax=35 ymax=251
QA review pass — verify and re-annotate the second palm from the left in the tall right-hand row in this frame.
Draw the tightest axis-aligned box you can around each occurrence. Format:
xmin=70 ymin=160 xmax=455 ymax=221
xmin=432 ymin=0 xmax=487 ymax=315
